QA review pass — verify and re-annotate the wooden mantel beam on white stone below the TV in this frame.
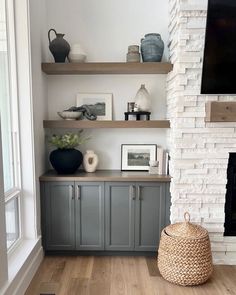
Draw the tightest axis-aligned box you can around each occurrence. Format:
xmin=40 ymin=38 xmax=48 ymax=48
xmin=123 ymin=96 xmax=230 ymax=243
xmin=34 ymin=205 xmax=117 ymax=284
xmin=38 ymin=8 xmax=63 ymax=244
xmin=205 ymin=101 xmax=236 ymax=122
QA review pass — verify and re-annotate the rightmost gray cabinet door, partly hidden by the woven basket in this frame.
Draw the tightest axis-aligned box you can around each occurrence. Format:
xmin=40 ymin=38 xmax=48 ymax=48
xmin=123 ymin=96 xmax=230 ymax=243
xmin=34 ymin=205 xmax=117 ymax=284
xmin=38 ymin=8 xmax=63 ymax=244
xmin=135 ymin=182 xmax=166 ymax=251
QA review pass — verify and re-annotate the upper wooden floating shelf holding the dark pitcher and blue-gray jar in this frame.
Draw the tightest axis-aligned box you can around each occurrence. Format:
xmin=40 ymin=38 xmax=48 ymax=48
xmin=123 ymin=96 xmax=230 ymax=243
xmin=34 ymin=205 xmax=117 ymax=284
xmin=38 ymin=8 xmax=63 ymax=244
xmin=42 ymin=62 xmax=173 ymax=75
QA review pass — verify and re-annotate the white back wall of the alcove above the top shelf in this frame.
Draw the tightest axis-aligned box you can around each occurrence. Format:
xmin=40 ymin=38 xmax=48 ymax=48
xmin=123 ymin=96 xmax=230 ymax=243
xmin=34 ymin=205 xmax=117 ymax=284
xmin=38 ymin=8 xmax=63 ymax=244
xmin=46 ymin=0 xmax=168 ymax=61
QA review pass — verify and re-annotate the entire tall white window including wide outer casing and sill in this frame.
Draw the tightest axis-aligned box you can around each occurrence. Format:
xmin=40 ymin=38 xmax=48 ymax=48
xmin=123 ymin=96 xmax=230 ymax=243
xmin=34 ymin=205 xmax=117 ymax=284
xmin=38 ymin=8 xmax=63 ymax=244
xmin=0 ymin=0 xmax=39 ymax=294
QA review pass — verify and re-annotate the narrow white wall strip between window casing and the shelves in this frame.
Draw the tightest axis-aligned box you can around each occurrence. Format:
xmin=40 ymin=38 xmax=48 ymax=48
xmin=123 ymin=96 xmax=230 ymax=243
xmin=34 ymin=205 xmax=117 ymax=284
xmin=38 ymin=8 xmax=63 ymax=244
xmin=29 ymin=0 xmax=47 ymax=233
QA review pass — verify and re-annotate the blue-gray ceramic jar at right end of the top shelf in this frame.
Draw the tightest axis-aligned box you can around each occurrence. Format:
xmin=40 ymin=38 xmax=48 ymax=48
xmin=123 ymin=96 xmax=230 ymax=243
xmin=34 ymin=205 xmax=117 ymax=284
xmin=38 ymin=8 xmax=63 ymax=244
xmin=141 ymin=33 xmax=164 ymax=62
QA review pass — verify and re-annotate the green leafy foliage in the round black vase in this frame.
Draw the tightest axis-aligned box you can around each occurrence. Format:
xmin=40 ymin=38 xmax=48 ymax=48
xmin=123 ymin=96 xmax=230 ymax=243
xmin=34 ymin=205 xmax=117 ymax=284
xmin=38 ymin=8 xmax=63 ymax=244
xmin=49 ymin=130 xmax=89 ymax=149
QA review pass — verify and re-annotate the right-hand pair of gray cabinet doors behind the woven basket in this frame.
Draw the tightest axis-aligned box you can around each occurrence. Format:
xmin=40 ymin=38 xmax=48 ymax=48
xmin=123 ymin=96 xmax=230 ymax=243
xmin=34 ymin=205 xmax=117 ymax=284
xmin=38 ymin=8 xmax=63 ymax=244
xmin=105 ymin=182 xmax=169 ymax=251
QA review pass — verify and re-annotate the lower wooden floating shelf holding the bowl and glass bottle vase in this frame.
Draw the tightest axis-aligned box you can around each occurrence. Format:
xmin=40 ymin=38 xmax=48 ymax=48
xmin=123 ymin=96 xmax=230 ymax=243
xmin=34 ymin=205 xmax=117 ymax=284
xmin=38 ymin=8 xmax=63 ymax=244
xmin=43 ymin=120 xmax=170 ymax=129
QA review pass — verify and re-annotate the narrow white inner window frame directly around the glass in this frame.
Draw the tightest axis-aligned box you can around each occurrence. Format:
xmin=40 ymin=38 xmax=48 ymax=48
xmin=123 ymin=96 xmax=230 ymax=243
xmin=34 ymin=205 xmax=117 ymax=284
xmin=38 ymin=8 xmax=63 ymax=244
xmin=3 ymin=0 xmax=23 ymax=255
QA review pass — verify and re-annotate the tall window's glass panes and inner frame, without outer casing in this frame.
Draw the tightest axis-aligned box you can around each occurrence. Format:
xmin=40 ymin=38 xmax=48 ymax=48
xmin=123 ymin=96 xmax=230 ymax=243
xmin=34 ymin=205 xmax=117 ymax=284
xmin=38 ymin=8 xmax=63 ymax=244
xmin=0 ymin=0 xmax=21 ymax=249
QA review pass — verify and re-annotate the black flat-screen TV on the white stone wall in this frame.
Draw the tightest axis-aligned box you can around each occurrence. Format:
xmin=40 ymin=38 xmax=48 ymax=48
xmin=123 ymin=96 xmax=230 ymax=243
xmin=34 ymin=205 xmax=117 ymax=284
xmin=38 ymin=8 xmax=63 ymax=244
xmin=201 ymin=0 xmax=236 ymax=94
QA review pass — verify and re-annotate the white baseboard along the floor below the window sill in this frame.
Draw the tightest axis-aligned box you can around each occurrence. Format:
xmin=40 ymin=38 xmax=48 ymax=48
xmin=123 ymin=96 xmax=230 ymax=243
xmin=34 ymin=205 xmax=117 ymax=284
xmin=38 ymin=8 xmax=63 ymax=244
xmin=3 ymin=239 xmax=44 ymax=295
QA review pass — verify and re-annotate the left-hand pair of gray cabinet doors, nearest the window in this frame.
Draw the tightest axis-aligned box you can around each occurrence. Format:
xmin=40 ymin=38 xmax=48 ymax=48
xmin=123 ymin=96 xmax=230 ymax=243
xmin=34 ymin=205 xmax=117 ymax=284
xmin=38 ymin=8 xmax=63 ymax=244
xmin=41 ymin=182 xmax=104 ymax=250
